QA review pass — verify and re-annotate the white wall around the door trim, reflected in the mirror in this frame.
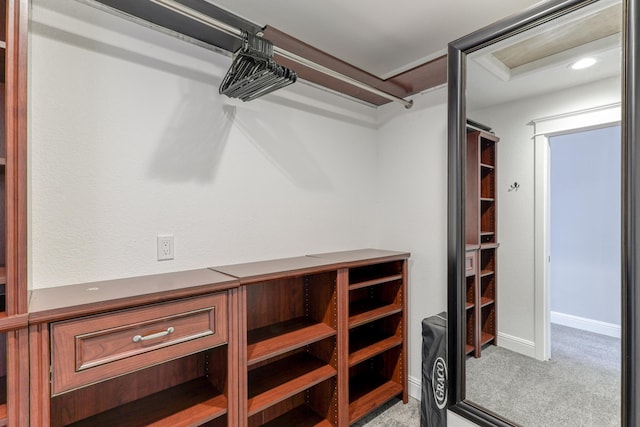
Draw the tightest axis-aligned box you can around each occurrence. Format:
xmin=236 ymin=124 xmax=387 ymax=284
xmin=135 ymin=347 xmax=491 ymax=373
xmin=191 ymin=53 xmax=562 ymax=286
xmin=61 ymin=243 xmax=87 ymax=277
xmin=470 ymin=78 xmax=621 ymax=354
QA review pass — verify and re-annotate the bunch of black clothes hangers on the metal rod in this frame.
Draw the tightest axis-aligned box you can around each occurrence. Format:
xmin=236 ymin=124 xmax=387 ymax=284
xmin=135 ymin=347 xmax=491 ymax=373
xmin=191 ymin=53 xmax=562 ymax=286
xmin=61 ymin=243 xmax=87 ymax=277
xmin=219 ymin=31 xmax=297 ymax=101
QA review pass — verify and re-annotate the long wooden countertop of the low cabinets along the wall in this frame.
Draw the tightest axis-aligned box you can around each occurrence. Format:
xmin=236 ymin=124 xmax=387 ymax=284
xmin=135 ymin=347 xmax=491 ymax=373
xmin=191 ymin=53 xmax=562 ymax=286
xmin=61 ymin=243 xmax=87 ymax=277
xmin=29 ymin=249 xmax=410 ymax=323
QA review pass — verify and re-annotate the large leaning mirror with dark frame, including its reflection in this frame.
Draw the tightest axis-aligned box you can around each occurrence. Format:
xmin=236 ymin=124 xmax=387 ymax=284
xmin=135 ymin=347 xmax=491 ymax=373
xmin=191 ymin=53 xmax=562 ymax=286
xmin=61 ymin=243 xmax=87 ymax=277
xmin=448 ymin=0 xmax=640 ymax=427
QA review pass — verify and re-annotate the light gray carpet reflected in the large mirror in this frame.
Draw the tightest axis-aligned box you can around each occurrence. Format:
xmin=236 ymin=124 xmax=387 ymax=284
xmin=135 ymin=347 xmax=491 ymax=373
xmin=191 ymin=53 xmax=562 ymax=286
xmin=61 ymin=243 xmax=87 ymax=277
xmin=466 ymin=324 xmax=621 ymax=427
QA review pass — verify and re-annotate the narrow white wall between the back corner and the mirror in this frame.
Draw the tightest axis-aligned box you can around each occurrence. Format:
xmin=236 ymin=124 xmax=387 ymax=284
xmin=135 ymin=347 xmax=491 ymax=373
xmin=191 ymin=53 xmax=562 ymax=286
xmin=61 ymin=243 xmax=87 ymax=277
xmin=377 ymin=88 xmax=447 ymax=396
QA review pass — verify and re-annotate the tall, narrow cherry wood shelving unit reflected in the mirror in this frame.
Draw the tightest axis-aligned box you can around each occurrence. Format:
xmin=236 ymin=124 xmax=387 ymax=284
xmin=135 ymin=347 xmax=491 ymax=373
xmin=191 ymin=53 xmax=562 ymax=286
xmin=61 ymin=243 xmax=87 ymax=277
xmin=465 ymin=131 xmax=499 ymax=357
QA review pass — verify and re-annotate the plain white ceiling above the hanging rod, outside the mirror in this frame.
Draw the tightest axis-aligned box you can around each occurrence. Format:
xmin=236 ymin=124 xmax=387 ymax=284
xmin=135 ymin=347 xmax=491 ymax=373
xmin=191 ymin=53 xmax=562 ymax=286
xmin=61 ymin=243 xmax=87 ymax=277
xmin=202 ymin=0 xmax=540 ymax=79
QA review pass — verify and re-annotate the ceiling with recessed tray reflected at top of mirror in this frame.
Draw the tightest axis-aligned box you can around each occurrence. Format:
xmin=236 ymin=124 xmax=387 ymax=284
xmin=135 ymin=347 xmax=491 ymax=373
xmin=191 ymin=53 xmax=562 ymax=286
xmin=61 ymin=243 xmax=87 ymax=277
xmin=467 ymin=0 xmax=622 ymax=112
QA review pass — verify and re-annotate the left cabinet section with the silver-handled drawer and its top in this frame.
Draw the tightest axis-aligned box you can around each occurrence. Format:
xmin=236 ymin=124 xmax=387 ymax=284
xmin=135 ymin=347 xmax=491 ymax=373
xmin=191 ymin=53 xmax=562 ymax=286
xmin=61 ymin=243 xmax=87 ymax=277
xmin=29 ymin=269 xmax=238 ymax=427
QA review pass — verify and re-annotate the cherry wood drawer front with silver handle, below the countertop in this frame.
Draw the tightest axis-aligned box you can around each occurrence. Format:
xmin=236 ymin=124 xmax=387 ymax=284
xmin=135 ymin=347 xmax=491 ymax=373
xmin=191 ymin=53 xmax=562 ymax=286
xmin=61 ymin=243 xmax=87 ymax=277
xmin=51 ymin=292 xmax=227 ymax=395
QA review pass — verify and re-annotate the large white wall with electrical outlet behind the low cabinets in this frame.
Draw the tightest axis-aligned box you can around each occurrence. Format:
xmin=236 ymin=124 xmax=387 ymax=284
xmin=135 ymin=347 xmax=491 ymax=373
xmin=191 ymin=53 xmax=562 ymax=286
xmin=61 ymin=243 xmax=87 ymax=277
xmin=29 ymin=0 xmax=380 ymax=288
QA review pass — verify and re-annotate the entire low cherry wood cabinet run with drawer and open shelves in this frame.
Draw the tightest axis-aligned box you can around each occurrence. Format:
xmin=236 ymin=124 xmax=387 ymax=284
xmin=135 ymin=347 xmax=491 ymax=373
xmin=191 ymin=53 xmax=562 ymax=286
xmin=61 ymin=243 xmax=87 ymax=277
xmin=29 ymin=249 xmax=409 ymax=427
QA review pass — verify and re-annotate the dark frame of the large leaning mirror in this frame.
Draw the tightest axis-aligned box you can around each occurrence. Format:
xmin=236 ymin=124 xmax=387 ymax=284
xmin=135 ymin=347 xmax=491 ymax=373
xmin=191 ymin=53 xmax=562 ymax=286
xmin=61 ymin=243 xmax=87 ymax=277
xmin=447 ymin=0 xmax=640 ymax=427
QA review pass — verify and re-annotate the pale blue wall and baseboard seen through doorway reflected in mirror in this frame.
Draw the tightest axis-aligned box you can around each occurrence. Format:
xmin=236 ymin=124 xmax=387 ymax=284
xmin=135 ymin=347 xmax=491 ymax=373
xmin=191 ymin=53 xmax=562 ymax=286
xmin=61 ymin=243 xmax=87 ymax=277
xmin=548 ymin=124 xmax=621 ymax=339
